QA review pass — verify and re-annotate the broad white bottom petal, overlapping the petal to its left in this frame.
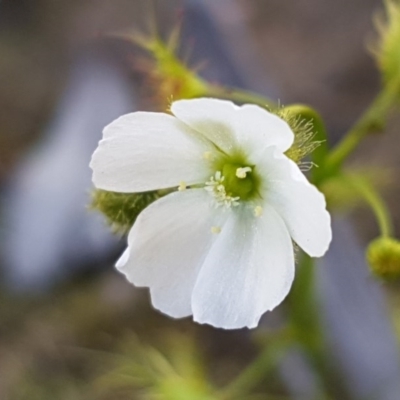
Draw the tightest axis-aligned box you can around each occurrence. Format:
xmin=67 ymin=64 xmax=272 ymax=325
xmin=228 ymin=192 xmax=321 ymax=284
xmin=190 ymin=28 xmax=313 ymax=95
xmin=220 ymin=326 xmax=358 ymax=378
xmin=192 ymin=205 xmax=294 ymax=329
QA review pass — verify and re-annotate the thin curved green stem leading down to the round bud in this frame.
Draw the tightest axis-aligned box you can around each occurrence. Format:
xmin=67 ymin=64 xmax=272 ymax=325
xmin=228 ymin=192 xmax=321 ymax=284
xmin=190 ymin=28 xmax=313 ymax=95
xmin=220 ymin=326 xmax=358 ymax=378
xmin=344 ymin=175 xmax=393 ymax=237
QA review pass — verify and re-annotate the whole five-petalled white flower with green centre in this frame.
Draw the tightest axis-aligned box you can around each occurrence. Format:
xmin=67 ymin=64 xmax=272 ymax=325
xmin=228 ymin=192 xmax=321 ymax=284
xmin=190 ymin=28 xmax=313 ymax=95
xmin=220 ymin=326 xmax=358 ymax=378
xmin=91 ymin=98 xmax=331 ymax=329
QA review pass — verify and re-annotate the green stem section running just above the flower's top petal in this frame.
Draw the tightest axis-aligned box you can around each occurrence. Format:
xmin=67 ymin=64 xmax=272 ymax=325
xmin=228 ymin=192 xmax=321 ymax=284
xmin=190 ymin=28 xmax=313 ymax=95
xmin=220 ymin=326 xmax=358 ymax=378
xmin=205 ymin=85 xmax=278 ymax=109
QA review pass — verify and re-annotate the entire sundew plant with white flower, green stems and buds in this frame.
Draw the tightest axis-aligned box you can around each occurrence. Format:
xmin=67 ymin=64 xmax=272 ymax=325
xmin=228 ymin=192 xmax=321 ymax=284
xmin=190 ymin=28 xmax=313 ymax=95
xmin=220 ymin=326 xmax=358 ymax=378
xmin=90 ymin=0 xmax=400 ymax=400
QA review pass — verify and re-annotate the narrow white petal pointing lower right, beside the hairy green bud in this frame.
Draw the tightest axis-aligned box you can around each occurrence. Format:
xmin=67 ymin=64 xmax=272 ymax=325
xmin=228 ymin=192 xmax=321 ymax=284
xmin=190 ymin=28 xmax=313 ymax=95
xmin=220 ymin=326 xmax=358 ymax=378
xmin=258 ymin=149 xmax=332 ymax=257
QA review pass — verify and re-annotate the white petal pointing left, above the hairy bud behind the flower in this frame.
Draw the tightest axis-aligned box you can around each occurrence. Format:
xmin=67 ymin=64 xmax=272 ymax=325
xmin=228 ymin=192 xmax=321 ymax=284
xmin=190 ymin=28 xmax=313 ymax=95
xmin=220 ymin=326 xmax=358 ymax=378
xmin=90 ymin=112 xmax=212 ymax=192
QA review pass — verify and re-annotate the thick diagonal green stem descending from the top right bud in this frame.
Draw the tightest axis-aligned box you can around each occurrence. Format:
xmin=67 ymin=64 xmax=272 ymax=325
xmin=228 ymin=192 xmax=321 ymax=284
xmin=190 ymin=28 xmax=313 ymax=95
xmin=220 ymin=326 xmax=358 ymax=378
xmin=327 ymin=84 xmax=399 ymax=171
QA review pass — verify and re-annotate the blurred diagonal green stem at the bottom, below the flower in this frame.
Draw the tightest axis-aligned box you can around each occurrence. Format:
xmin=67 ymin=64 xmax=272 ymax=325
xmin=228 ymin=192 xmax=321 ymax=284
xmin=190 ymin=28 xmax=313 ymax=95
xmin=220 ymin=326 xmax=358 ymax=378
xmin=219 ymin=334 xmax=293 ymax=399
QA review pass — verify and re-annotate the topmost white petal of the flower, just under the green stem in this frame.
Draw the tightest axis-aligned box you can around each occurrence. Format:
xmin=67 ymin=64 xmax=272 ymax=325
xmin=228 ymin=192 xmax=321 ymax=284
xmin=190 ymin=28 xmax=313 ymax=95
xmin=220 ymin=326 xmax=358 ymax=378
xmin=171 ymin=98 xmax=294 ymax=157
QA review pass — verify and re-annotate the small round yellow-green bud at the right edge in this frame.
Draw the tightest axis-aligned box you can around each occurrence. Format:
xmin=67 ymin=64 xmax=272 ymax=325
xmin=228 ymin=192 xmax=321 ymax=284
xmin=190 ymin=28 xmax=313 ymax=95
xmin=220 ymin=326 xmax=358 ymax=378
xmin=366 ymin=237 xmax=400 ymax=280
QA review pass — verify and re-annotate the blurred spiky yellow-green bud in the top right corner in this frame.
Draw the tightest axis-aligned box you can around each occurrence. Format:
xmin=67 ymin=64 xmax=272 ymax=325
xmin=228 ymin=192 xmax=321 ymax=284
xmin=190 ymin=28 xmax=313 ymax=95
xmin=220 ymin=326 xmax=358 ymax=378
xmin=371 ymin=0 xmax=400 ymax=84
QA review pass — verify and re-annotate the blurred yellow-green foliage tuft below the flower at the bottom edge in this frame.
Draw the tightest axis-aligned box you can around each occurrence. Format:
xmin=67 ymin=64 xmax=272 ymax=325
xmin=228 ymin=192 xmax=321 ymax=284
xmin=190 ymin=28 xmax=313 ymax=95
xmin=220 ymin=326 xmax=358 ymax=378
xmin=97 ymin=331 xmax=217 ymax=400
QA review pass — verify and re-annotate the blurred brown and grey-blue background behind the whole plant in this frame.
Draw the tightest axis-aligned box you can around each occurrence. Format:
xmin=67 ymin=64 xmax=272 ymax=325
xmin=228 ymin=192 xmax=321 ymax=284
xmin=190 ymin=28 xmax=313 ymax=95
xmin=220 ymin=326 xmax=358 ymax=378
xmin=0 ymin=0 xmax=400 ymax=400
